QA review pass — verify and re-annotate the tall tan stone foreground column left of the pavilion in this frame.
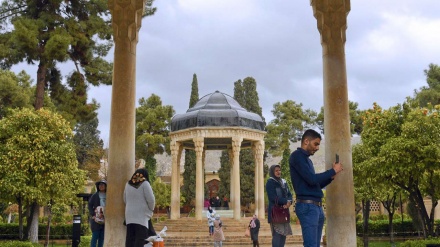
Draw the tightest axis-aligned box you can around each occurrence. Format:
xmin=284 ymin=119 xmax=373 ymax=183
xmin=104 ymin=0 xmax=144 ymax=247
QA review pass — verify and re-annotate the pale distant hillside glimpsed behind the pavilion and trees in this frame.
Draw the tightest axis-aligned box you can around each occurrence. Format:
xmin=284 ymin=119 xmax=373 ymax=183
xmin=155 ymin=136 xmax=361 ymax=176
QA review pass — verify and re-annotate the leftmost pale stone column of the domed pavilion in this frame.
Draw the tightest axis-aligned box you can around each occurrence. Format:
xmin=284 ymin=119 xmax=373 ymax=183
xmin=170 ymin=141 xmax=182 ymax=220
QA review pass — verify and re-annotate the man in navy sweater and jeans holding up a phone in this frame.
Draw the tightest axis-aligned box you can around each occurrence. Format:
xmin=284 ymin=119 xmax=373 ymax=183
xmin=289 ymin=129 xmax=342 ymax=247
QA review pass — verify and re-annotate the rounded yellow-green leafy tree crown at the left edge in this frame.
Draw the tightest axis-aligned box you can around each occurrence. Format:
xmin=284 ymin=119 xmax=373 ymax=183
xmin=0 ymin=109 xmax=85 ymax=239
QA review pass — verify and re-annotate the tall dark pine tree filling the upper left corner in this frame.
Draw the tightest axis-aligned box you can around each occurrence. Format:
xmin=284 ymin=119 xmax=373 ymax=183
xmin=0 ymin=0 xmax=117 ymax=109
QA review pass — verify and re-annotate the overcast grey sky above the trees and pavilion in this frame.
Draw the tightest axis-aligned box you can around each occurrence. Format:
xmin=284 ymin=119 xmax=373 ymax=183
xmin=12 ymin=0 xmax=440 ymax=146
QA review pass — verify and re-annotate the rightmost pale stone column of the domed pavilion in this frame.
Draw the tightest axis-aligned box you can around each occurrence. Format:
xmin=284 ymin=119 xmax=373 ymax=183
xmin=254 ymin=141 xmax=266 ymax=219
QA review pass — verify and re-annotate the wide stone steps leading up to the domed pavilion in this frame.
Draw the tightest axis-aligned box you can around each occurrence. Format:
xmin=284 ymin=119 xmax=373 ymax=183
xmin=153 ymin=217 xmax=302 ymax=247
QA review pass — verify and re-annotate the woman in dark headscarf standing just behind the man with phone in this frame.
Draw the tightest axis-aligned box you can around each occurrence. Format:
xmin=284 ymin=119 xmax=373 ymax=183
xmin=266 ymin=165 xmax=292 ymax=247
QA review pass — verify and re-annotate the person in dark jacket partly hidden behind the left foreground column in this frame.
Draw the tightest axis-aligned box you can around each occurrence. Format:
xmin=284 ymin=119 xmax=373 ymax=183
xmin=88 ymin=180 xmax=107 ymax=247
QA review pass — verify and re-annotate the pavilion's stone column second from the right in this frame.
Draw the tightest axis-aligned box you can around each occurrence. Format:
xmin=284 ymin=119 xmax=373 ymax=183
xmin=232 ymin=137 xmax=243 ymax=220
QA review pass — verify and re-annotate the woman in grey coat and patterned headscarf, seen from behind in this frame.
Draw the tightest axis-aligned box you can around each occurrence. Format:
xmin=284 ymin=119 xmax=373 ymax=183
xmin=124 ymin=169 xmax=156 ymax=247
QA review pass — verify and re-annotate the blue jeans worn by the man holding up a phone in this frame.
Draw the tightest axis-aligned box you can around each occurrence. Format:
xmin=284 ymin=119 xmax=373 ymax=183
xmin=295 ymin=203 xmax=325 ymax=247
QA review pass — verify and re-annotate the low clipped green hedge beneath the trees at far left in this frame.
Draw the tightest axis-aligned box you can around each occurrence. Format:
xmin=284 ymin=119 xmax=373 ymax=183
xmin=0 ymin=223 xmax=89 ymax=239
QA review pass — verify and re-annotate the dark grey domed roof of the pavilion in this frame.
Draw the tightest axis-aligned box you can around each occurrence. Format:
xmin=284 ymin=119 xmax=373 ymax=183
xmin=171 ymin=91 xmax=266 ymax=131
